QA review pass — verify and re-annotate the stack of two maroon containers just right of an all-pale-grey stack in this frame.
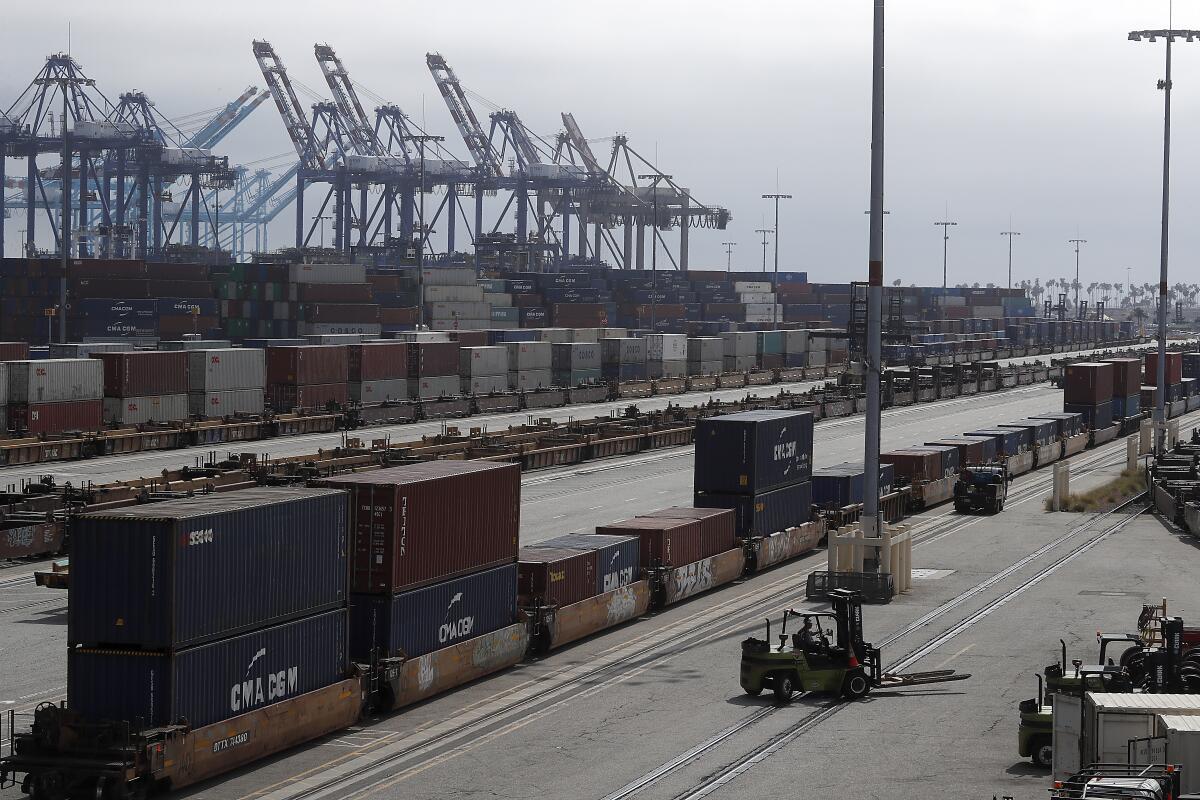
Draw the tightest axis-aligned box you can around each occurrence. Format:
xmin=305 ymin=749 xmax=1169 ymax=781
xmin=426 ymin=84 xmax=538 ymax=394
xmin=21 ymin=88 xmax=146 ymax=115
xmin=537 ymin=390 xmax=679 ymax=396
xmin=266 ymin=344 xmax=349 ymax=414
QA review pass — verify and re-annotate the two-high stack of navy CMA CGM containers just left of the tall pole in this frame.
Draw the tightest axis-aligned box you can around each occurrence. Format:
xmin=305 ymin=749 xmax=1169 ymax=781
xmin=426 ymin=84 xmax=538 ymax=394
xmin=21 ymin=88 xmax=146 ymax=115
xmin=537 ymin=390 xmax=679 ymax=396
xmin=695 ymin=411 xmax=812 ymax=537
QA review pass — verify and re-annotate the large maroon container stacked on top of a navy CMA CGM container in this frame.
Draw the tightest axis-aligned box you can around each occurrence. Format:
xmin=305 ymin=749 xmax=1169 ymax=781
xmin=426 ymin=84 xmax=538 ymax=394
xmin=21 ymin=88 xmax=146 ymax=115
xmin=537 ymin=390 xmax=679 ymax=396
xmin=318 ymin=461 xmax=521 ymax=594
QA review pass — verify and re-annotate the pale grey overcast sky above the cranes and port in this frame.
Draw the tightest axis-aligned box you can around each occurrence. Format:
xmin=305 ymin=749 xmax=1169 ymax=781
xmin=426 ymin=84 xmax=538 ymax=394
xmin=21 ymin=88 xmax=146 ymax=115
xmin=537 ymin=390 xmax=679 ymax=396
xmin=0 ymin=0 xmax=1200 ymax=284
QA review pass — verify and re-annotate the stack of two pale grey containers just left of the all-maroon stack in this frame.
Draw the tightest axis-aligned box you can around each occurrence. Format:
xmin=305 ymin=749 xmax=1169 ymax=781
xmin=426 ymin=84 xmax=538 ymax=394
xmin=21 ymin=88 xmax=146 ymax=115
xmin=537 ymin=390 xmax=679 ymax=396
xmin=187 ymin=348 xmax=266 ymax=419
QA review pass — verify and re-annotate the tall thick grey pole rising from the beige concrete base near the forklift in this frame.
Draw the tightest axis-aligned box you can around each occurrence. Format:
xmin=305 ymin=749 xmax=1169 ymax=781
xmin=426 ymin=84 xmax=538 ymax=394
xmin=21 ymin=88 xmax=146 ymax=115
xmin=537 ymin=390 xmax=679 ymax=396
xmin=862 ymin=0 xmax=892 ymax=575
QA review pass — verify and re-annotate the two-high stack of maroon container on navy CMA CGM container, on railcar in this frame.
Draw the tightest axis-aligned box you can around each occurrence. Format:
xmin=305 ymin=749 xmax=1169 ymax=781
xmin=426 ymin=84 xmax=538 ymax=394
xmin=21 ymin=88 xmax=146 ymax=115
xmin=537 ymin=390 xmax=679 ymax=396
xmin=320 ymin=461 xmax=521 ymax=663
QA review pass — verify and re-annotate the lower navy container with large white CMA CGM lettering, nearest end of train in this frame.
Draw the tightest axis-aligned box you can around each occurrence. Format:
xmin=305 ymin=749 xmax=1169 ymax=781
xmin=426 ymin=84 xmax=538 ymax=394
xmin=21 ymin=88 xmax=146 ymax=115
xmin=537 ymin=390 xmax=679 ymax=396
xmin=67 ymin=606 xmax=349 ymax=728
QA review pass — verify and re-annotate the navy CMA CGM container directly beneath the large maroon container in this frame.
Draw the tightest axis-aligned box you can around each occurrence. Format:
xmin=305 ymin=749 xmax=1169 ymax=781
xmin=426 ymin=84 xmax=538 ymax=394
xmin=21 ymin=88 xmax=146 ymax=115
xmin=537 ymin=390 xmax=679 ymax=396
xmin=350 ymin=564 xmax=517 ymax=663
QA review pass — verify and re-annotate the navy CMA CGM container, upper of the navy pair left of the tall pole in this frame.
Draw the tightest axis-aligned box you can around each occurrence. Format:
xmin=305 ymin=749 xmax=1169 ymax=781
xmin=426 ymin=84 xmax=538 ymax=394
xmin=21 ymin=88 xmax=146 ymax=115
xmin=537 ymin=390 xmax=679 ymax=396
xmin=695 ymin=410 xmax=812 ymax=494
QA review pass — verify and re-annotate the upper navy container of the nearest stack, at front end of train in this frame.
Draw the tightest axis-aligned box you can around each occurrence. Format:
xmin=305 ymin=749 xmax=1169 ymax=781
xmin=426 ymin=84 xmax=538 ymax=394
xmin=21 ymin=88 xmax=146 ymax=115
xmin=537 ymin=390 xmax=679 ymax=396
xmin=68 ymin=488 xmax=348 ymax=649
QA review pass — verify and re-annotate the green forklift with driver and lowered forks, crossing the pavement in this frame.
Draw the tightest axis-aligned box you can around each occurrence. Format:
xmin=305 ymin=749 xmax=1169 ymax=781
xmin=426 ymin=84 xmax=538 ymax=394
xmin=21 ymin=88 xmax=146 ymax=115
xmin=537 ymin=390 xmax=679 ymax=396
xmin=740 ymin=589 xmax=971 ymax=703
